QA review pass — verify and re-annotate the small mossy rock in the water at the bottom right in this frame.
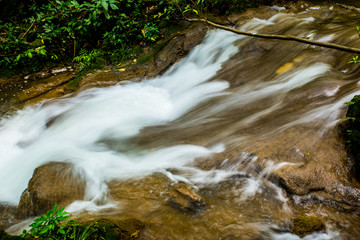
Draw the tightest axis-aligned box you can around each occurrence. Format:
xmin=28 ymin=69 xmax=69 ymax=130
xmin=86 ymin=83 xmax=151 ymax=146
xmin=291 ymin=216 xmax=325 ymax=237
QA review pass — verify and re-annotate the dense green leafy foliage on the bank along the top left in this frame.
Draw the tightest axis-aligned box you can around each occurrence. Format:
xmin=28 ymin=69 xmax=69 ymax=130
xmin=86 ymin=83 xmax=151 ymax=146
xmin=0 ymin=0 xmax=268 ymax=73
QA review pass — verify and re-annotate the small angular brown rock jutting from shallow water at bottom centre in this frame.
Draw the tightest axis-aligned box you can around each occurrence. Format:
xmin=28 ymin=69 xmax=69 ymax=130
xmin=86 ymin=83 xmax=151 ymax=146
xmin=168 ymin=183 xmax=205 ymax=212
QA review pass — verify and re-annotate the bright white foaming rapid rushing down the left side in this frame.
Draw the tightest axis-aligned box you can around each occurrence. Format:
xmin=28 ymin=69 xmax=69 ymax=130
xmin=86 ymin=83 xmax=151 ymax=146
xmin=0 ymin=31 xmax=240 ymax=204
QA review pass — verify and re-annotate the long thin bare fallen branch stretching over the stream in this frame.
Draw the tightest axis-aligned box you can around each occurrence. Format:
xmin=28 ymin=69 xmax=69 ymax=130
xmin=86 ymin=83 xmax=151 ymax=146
xmin=186 ymin=18 xmax=360 ymax=53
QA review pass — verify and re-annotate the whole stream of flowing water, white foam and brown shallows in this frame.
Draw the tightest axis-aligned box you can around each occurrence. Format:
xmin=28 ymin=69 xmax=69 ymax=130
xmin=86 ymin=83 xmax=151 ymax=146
xmin=0 ymin=2 xmax=360 ymax=239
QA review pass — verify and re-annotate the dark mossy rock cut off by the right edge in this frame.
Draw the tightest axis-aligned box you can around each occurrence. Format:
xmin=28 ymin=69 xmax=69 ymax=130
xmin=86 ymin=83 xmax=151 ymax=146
xmin=346 ymin=95 xmax=360 ymax=180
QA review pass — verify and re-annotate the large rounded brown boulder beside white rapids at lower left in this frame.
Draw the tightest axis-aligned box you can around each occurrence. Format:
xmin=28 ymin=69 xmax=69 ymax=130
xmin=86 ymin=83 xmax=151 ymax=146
xmin=18 ymin=162 xmax=85 ymax=217
